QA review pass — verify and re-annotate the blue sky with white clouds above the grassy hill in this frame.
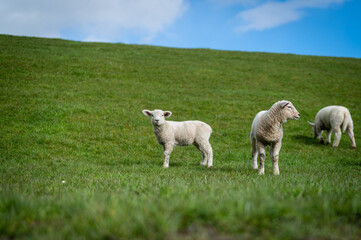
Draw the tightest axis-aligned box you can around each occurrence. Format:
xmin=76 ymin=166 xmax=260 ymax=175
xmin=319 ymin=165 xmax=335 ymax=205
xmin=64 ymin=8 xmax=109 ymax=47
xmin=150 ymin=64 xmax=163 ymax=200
xmin=0 ymin=0 xmax=361 ymax=58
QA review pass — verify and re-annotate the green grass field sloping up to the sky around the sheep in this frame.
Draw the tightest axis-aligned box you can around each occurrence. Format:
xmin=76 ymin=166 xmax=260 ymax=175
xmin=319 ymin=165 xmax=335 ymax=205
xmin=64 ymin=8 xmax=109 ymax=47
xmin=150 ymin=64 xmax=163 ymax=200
xmin=0 ymin=35 xmax=361 ymax=240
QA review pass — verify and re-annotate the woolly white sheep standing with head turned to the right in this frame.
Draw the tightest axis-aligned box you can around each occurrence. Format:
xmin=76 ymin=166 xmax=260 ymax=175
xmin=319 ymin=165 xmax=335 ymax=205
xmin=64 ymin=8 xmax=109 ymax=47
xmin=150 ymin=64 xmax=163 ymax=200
xmin=251 ymin=100 xmax=300 ymax=175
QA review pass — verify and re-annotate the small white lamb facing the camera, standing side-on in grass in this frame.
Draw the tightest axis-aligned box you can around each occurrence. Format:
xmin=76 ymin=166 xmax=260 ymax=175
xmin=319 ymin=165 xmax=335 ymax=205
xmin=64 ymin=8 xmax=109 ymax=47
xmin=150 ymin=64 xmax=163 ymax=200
xmin=142 ymin=109 xmax=213 ymax=168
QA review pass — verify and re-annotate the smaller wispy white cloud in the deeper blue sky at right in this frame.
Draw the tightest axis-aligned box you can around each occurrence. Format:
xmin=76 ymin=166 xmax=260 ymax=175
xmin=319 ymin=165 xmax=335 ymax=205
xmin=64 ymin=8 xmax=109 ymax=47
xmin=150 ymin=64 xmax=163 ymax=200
xmin=237 ymin=0 xmax=346 ymax=32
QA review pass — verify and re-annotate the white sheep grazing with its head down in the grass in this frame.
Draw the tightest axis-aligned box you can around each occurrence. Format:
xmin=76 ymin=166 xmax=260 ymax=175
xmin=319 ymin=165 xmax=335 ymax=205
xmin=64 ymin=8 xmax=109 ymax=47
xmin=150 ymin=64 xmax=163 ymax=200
xmin=308 ymin=106 xmax=356 ymax=149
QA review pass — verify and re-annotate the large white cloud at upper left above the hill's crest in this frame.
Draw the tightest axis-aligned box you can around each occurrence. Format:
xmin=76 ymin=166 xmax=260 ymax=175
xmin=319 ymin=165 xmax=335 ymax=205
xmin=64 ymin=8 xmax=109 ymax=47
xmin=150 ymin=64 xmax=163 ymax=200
xmin=0 ymin=0 xmax=187 ymax=41
